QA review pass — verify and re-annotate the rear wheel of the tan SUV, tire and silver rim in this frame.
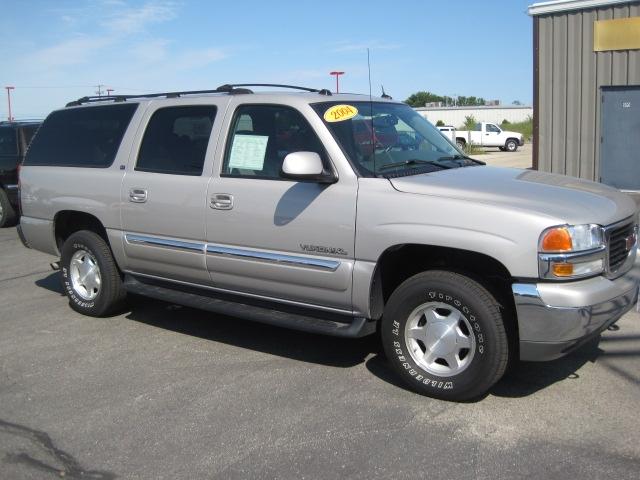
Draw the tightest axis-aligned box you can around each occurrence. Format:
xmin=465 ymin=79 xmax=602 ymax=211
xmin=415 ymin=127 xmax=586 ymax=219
xmin=60 ymin=230 xmax=126 ymax=317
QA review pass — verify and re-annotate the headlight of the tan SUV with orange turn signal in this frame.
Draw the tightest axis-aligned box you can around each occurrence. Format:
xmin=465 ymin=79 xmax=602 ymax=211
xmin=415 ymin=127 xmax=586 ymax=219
xmin=538 ymin=225 xmax=606 ymax=280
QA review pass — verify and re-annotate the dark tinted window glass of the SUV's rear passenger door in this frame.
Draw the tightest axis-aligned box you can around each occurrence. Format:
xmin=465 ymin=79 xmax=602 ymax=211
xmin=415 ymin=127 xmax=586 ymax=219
xmin=136 ymin=105 xmax=216 ymax=175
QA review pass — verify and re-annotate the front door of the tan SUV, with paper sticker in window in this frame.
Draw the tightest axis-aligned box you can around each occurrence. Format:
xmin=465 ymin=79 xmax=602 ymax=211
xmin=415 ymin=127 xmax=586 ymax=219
xmin=206 ymin=100 xmax=357 ymax=312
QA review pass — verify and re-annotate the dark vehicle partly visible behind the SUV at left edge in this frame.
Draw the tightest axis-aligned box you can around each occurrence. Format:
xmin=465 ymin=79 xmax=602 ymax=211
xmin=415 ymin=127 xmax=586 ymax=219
xmin=0 ymin=121 xmax=41 ymax=228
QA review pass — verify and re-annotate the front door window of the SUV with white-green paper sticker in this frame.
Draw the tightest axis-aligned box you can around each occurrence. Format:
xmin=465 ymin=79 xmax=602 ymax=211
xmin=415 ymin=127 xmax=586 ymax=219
xmin=222 ymin=105 xmax=326 ymax=179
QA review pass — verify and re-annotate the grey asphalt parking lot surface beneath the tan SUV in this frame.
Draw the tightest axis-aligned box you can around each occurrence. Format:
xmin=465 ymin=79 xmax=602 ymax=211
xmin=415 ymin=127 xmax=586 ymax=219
xmin=0 ymin=226 xmax=640 ymax=479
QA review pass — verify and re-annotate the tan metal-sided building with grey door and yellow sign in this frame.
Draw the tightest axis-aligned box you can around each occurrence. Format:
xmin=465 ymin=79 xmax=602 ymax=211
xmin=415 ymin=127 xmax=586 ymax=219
xmin=529 ymin=0 xmax=640 ymax=191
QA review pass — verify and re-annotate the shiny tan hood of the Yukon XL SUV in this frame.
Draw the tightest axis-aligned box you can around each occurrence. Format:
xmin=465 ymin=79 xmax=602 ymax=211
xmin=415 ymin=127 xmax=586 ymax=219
xmin=390 ymin=166 xmax=637 ymax=225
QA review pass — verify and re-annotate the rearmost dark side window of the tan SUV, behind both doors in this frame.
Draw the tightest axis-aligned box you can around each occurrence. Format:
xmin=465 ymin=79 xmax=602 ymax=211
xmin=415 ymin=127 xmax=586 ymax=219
xmin=24 ymin=104 xmax=137 ymax=168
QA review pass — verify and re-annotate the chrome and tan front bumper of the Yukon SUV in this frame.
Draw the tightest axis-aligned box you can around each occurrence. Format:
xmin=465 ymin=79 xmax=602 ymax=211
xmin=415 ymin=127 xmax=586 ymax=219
xmin=512 ymin=269 xmax=640 ymax=361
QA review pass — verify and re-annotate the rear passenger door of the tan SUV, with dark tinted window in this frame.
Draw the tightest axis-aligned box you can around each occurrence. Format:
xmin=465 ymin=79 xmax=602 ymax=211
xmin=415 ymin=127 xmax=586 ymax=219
xmin=121 ymin=100 xmax=220 ymax=283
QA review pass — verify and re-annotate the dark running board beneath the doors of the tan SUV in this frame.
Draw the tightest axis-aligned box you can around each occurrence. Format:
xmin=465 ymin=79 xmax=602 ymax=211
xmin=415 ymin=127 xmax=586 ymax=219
xmin=124 ymin=274 xmax=376 ymax=338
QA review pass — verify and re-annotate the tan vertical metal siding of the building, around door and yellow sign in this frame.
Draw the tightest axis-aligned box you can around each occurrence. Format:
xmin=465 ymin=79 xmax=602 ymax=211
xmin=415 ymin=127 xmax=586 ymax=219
xmin=535 ymin=1 xmax=640 ymax=180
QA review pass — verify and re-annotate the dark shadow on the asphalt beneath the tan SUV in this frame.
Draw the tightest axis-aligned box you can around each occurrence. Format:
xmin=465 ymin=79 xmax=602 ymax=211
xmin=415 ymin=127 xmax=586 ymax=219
xmin=35 ymin=273 xmax=640 ymax=400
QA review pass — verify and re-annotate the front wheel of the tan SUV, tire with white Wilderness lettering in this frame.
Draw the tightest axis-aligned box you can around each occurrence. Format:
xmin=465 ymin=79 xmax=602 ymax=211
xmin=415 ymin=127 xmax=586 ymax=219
xmin=380 ymin=270 xmax=509 ymax=401
